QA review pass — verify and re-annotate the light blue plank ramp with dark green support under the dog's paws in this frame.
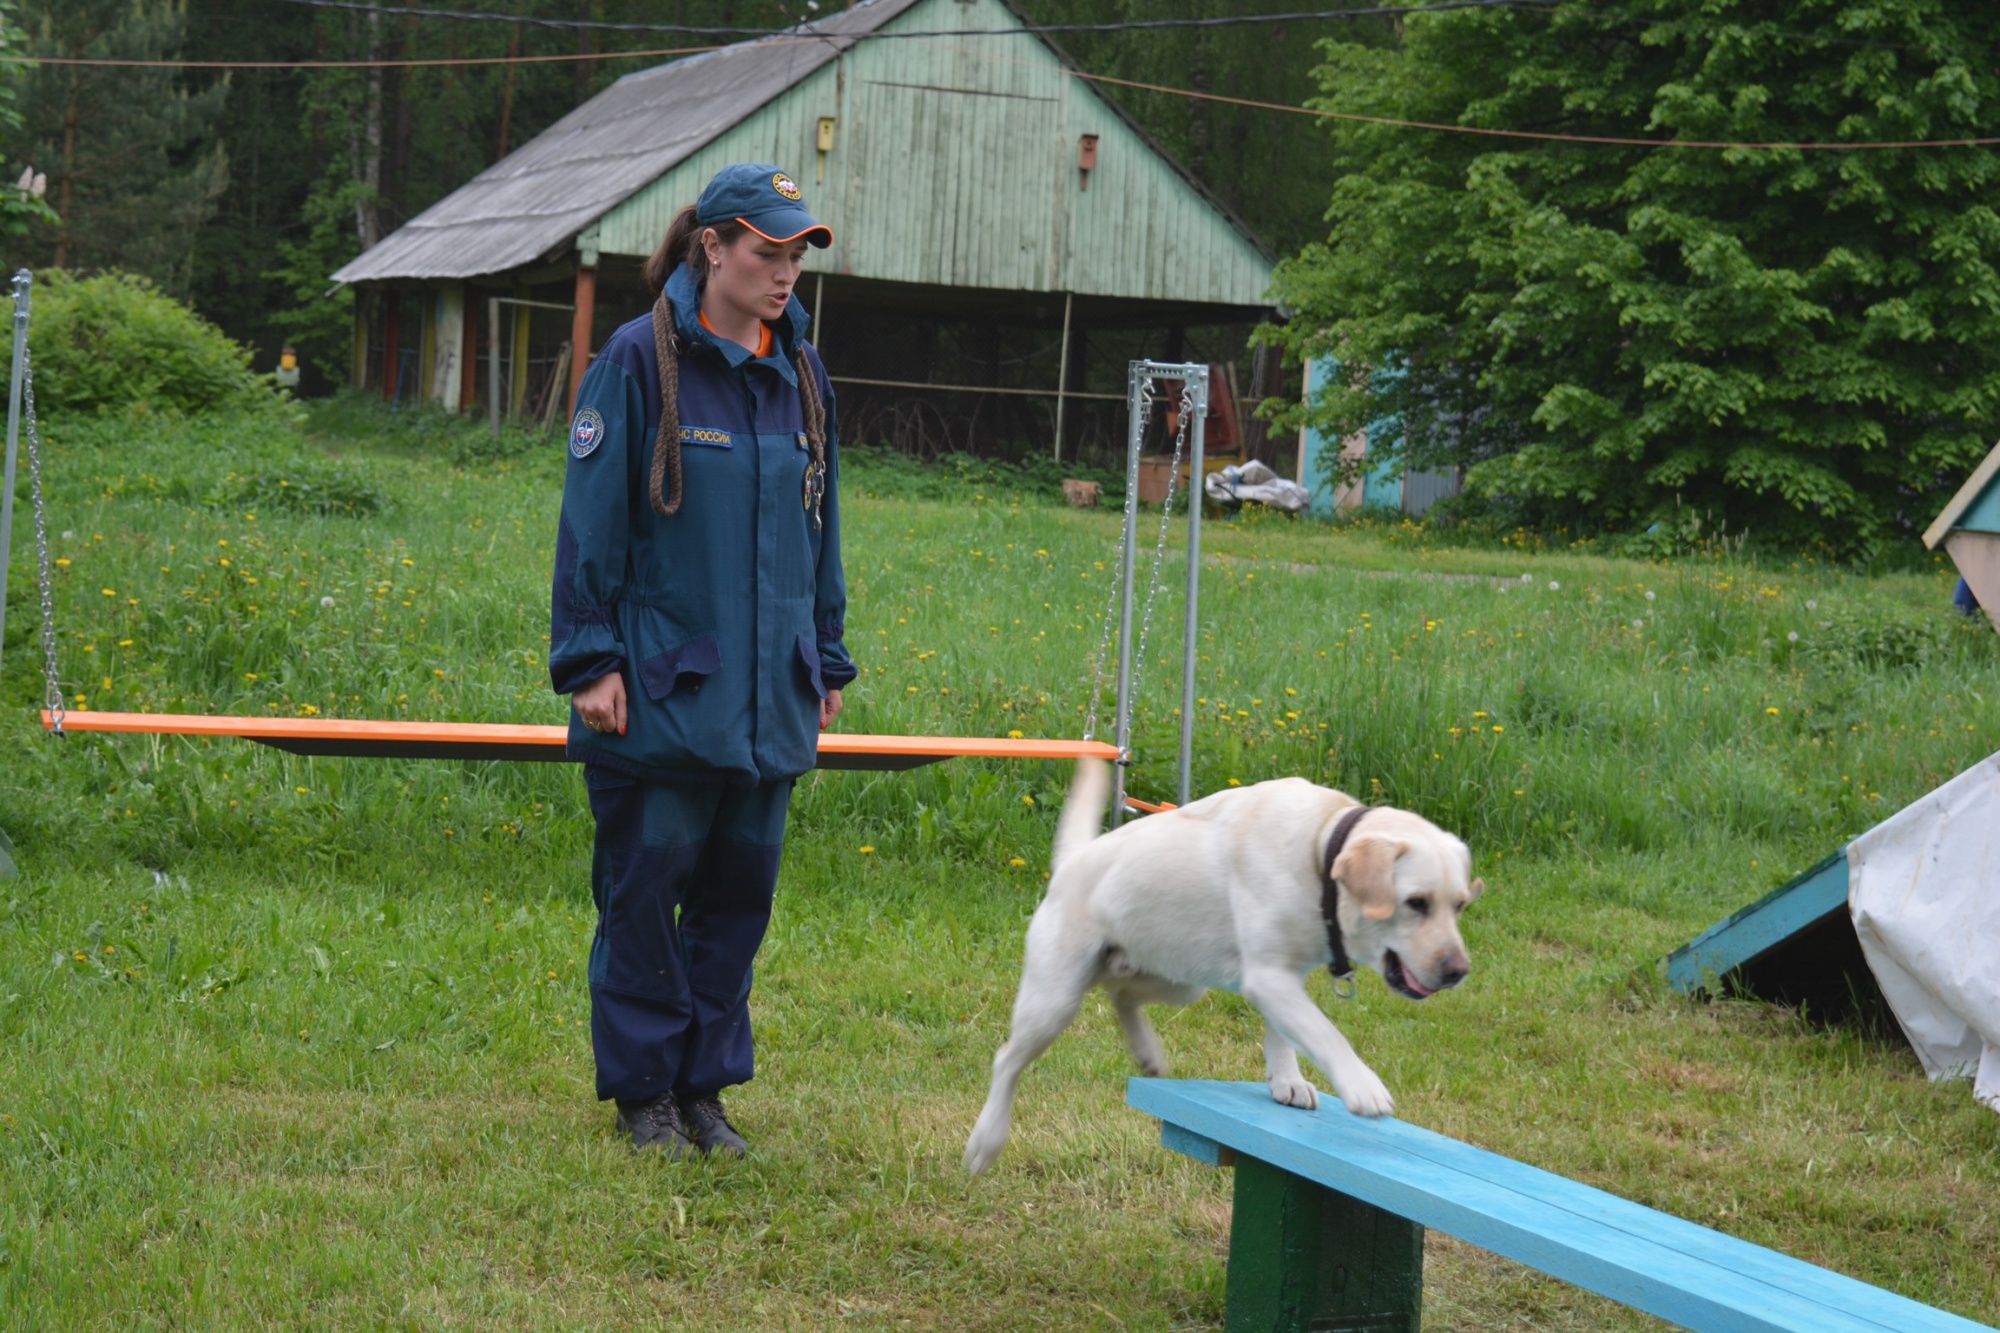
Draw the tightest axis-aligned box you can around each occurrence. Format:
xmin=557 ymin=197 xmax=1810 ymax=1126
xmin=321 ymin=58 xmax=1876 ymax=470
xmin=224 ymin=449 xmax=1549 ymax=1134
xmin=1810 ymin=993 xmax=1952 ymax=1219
xmin=1126 ymin=1079 xmax=1994 ymax=1333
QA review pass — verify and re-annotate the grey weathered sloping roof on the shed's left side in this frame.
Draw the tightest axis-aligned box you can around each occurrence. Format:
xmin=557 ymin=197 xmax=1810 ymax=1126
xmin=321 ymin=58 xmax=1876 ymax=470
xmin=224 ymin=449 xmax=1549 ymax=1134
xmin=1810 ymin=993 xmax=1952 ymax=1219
xmin=334 ymin=0 xmax=920 ymax=282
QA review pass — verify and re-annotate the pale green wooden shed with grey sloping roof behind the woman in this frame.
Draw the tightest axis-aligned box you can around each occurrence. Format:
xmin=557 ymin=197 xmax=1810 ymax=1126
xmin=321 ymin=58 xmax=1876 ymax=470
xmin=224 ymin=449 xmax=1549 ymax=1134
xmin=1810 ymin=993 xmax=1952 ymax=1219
xmin=334 ymin=0 xmax=1272 ymax=456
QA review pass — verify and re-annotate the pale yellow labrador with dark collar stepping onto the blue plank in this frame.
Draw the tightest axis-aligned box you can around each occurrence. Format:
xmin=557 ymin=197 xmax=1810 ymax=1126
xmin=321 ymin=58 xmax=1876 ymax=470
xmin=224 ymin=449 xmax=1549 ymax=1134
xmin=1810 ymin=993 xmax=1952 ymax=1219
xmin=966 ymin=761 xmax=1484 ymax=1173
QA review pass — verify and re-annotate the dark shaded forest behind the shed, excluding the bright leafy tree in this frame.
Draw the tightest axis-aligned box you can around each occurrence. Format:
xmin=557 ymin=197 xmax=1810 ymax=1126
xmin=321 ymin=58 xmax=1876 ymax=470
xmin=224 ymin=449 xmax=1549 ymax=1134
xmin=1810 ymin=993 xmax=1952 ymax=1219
xmin=0 ymin=0 xmax=1360 ymax=392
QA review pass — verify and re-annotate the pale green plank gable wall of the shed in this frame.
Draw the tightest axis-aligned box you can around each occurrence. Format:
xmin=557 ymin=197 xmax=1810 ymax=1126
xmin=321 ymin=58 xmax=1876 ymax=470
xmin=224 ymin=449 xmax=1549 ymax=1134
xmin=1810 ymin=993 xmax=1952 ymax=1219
xmin=596 ymin=0 xmax=1270 ymax=306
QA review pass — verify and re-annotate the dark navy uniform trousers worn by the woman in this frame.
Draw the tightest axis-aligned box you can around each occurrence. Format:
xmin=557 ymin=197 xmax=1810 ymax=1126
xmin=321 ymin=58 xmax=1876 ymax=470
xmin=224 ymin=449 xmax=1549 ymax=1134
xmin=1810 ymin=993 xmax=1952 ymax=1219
xmin=584 ymin=765 xmax=792 ymax=1101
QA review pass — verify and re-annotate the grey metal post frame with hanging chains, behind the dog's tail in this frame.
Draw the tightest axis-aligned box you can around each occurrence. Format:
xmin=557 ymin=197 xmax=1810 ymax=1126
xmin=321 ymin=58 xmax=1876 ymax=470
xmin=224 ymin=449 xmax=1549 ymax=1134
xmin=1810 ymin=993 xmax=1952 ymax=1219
xmin=1110 ymin=360 xmax=1208 ymax=827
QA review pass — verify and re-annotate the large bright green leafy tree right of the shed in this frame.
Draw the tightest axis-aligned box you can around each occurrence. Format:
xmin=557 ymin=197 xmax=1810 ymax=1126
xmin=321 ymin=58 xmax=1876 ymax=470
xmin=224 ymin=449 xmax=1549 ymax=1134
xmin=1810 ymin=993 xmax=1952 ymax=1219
xmin=1278 ymin=0 xmax=2000 ymax=552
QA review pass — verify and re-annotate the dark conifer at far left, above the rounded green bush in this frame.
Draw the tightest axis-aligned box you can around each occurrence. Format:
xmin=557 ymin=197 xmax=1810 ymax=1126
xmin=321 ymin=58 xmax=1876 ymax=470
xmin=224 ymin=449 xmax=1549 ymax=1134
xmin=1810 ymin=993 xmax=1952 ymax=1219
xmin=8 ymin=0 xmax=228 ymax=292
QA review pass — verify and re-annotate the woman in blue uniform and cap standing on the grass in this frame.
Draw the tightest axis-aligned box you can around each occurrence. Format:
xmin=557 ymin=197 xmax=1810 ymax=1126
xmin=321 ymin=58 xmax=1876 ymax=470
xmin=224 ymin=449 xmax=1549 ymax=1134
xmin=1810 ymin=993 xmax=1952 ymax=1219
xmin=550 ymin=164 xmax=856 ymax=1157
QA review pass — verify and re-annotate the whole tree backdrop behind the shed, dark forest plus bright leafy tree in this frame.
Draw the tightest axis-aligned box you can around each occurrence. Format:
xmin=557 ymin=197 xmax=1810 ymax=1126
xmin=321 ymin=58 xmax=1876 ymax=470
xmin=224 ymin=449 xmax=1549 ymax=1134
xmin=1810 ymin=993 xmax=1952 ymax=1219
xmin=0 ymin=0 xmax=2000 ymax=560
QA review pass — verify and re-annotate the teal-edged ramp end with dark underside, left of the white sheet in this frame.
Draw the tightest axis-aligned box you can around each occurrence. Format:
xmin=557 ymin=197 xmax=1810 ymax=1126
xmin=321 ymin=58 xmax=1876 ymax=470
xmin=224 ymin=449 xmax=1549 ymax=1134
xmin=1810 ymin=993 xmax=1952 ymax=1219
xmin=1666 ymin=851 xmax=1880 ymax=1017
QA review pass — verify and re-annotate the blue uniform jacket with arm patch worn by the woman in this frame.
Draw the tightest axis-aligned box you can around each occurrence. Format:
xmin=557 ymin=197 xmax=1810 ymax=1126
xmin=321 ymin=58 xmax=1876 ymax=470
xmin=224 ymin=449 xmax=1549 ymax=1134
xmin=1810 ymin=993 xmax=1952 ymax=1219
xmin=548 ymin=268 xmax=858 ymax=783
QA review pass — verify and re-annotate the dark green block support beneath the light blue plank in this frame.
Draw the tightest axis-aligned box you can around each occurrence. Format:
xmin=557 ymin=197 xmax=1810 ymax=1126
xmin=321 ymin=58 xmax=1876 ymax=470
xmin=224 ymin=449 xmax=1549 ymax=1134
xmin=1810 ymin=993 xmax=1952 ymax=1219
xmin=1226 ymin=1157 xmax=1424 ymax=1333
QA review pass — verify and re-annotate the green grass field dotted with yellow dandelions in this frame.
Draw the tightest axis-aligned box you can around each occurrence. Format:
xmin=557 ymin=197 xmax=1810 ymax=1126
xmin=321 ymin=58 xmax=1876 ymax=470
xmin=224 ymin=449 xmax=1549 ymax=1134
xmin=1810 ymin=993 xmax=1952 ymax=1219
xmin=0 ymin=406 xmax=2000 ymax=1333
